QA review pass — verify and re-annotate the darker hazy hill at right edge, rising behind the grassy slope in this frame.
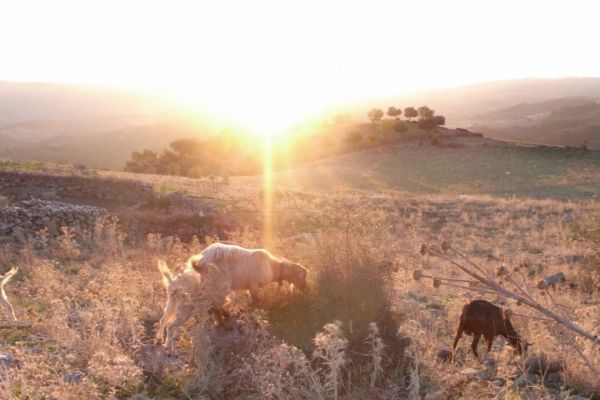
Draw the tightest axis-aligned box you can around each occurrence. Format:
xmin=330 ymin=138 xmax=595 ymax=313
xmin=475 ymin=98 xmax=600 ymax=149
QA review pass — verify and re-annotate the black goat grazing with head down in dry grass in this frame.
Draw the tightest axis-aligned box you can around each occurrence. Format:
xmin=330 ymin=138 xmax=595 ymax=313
xmin=452 ymin=300 xmax=531 ymax=359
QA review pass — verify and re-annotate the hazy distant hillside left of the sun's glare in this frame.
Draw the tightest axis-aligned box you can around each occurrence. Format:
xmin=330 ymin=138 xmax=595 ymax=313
xmin=0 ymin=82 xmax=220 ymax=169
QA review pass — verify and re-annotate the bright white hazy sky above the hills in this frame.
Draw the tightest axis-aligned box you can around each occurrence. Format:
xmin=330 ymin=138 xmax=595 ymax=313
xmin=0 ymin=0 xmax=600 ymax=128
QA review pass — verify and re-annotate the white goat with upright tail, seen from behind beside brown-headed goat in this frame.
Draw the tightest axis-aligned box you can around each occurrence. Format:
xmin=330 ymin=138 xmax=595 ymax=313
xmin=156 ymin=260 xmax=201 ymax=352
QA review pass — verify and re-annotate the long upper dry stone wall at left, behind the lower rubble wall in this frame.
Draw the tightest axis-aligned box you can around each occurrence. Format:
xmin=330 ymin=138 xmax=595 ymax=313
xmin=0 ymin=171 xmax=153 ymax=204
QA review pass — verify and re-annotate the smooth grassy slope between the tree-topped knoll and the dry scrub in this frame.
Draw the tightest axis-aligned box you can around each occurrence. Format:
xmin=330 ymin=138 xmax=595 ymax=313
xmin=96 ymin=141 xmax=600 ymax=200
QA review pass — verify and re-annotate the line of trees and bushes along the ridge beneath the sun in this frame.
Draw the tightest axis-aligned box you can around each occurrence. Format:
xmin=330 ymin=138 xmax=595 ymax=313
xmin=125 ymin=106 xmax=445 ymax=178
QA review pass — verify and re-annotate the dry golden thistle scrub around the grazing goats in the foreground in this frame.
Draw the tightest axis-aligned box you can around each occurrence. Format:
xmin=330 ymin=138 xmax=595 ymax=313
xmin=0 ymin=185 xmax=600 ymax=399
